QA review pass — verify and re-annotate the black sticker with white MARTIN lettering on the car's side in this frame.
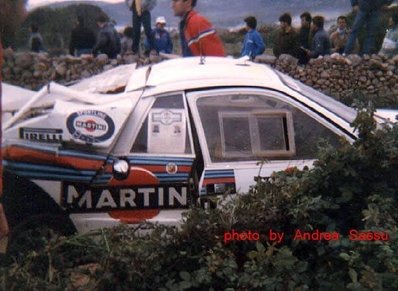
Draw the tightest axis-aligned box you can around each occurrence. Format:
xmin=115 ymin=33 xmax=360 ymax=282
xmin=62 ymin=184 xmax=189 ymax=213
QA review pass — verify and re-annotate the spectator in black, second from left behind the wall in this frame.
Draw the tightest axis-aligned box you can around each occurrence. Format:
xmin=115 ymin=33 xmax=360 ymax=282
xmin=69 ymin=15 xmax=96 ymax=57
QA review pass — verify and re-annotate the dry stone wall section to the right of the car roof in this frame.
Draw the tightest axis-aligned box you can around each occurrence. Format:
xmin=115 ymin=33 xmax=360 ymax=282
xmin=256 ymin=54 xmax=398 ymax=105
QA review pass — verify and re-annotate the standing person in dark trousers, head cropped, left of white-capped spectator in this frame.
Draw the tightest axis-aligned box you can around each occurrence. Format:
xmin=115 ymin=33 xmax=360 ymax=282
xmin=125 ymin=0 xmax=157 ymax=55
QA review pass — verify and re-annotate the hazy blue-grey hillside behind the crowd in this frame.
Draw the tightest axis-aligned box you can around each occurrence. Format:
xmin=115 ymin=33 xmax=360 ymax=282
xmin=44 ymin=0 xmax=350 ymax=28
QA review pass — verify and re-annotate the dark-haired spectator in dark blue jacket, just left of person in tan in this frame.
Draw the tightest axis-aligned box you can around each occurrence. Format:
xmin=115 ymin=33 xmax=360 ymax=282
xmin=307 ymin=16 xmax=330 ymax=58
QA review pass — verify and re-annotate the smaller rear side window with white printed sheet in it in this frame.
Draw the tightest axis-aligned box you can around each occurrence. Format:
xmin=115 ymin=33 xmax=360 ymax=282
xmin=131 ymin=95 xmax=192 ymax=154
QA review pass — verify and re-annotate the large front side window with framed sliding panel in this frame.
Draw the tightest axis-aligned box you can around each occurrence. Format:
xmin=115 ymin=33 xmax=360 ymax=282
xmin=197 ymin=94 xmax=339 ymax=162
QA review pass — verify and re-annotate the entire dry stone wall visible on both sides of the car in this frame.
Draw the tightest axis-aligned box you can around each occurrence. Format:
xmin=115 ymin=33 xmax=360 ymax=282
xmin=2 ymin=50 xmax=398 ymax=105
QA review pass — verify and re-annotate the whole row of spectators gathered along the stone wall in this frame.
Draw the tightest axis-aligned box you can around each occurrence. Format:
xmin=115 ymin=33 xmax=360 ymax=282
xmin=24 ymin=0 xmax=398 ymax=64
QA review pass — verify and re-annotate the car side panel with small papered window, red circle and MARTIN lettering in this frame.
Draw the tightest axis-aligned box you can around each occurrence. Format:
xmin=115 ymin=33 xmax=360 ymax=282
xmin=65 ymin=93 xmax=195 ymax=230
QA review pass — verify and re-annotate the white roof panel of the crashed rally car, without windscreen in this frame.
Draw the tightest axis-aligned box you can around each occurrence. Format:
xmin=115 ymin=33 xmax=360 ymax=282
xmin=126 ymin=57 xmax=284 ymax=94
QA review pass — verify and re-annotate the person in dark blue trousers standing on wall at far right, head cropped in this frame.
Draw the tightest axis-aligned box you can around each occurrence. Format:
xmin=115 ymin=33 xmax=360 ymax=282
xmin=344 ymin=0 xmax=393 ymax=54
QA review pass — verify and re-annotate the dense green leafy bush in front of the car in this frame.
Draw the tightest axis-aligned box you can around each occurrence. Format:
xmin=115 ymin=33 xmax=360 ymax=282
xmin=0 ymin=109 xmax=398 ymax=290
